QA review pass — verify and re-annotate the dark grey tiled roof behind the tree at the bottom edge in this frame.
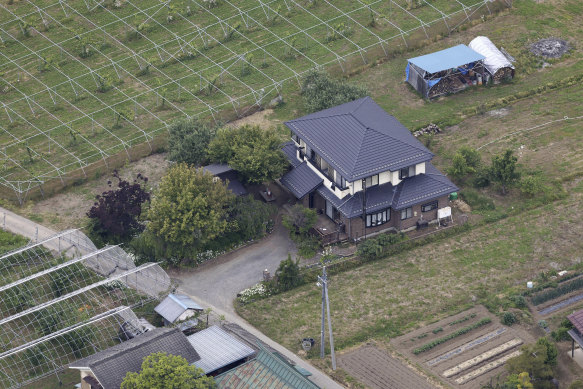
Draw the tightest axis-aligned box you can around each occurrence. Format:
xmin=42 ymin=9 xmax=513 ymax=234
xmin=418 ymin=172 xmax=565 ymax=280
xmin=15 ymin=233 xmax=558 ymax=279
xmin=69 ymin=328 xmax=200 ymax=389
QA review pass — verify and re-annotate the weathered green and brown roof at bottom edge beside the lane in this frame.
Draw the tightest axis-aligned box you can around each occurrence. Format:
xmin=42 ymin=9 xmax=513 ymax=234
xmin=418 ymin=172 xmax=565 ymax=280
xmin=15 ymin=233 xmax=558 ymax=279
xmin=215 ymin=348 xmax=319 ymax=389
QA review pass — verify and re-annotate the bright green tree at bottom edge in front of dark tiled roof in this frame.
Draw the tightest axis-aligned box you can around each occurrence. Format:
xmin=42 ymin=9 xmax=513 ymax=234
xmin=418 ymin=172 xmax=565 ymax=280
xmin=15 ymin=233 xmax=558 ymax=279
xmin=121 ymin=353 xmax=216 ymax=389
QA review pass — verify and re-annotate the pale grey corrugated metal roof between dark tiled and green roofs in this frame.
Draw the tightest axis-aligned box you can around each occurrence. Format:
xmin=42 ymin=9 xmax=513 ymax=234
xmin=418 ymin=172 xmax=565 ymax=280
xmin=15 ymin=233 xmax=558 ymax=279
xmin=188 ymin=326 xmax=255 ymax=374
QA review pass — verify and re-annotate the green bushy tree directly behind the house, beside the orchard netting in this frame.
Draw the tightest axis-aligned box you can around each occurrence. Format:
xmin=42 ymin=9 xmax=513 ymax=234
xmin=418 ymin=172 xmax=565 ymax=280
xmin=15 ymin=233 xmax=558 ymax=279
xmin=302 ymin=70 xmax=369 ymax=112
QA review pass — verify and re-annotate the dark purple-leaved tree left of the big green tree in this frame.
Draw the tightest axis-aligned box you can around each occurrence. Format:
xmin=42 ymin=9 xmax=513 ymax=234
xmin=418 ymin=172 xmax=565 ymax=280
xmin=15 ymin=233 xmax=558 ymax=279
xmin=87 ymin=171 xmax=150 ymax=244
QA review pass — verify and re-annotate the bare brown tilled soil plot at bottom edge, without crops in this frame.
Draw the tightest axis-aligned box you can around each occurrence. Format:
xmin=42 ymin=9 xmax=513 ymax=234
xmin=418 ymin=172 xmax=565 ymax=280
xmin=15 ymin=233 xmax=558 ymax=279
xmin=338 ymin=344 xmax=436 ymax=389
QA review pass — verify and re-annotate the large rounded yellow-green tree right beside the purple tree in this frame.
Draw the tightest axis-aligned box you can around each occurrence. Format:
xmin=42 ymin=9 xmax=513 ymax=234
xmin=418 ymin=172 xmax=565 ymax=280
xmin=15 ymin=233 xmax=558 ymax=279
xmin=147 ymin=163 xmax=233 ymax=257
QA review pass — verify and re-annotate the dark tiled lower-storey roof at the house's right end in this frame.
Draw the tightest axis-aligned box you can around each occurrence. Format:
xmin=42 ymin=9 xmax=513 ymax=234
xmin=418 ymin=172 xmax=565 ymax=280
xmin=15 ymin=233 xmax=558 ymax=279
xmin=393 ymin=163 xmax=458 ymax=210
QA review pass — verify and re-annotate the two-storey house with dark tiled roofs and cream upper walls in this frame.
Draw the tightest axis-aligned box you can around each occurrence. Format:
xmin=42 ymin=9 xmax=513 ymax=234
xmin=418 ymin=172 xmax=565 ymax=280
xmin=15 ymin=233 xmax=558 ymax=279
xmin=281 ymin=97 xmax=458 ymax=239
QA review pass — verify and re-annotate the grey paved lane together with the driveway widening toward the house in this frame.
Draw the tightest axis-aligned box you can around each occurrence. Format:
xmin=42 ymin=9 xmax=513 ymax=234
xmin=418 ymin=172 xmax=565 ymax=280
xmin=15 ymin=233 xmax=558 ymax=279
xmin=0 ymin=207 xmax=342 ymax=389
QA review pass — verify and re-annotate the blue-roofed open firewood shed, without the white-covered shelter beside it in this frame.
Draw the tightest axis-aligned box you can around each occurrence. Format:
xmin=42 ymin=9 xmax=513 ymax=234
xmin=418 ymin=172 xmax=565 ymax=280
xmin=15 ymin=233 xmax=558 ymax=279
xmin=405 ymin=45 xmax=484 ymax=98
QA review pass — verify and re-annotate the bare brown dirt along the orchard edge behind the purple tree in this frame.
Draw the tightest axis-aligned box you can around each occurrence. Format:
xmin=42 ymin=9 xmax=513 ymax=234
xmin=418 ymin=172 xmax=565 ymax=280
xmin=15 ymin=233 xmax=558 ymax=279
xmin=26 ymin=154 xmax=168 ymax=230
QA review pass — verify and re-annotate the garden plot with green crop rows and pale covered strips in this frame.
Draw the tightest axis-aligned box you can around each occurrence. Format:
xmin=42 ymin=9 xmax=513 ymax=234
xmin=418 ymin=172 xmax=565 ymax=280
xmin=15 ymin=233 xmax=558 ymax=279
xmin=391 ymin=306 xmax=532 ymax=388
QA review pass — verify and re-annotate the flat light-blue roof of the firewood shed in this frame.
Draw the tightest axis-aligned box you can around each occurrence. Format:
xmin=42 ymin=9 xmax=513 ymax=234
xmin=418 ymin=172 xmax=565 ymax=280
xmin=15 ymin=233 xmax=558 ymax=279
xmin=408 ymin=45 xmax=485 ymax=73
